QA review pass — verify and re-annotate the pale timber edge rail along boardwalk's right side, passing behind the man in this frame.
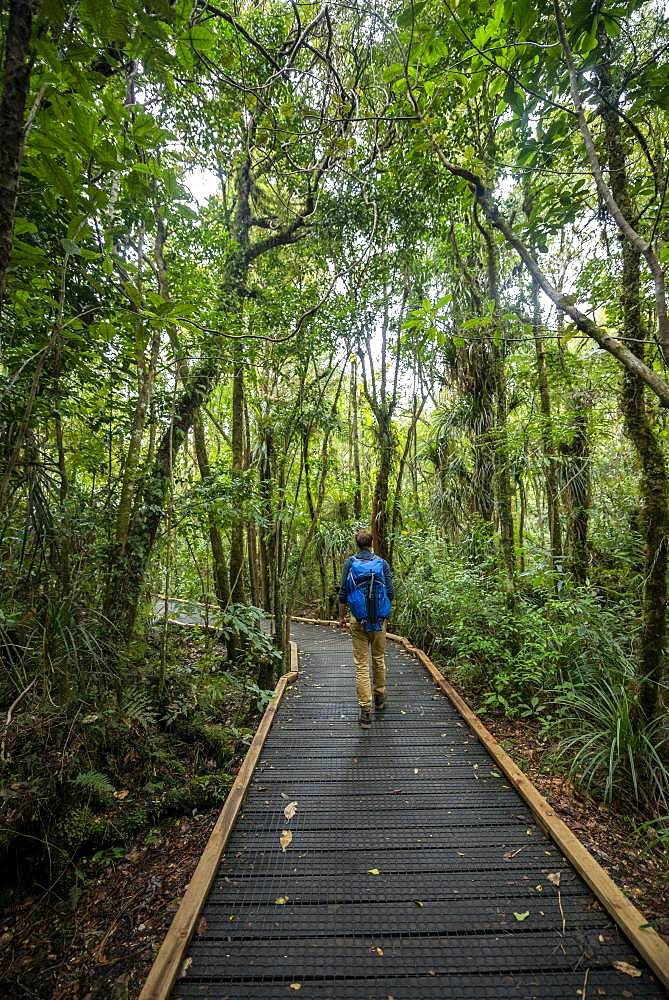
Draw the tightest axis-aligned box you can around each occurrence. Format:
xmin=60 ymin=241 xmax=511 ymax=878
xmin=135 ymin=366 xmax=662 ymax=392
xmin=294 ymin=617 xmax=669 ymax=991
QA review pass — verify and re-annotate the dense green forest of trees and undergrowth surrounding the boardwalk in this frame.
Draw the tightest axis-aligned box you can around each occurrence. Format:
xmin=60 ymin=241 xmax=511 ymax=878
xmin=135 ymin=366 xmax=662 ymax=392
xmin=0 ymin=0 xmax=669 ymax=924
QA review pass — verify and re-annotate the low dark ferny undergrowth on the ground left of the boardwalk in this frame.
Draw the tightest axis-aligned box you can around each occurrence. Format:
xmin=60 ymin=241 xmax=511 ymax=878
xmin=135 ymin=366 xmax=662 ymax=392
xmin=0 ymin=616 xmax=275 ymax=903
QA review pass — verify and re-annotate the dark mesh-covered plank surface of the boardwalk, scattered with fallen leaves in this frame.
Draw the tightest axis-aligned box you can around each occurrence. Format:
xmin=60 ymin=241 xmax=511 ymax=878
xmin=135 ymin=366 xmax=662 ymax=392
xmin=173 ymin=624 xmax=664 ymax=1000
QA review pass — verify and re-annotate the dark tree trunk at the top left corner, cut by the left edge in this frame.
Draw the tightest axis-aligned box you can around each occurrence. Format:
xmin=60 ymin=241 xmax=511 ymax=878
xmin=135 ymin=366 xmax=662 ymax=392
xmin=0 ymin=0 xmax=34 ymax=315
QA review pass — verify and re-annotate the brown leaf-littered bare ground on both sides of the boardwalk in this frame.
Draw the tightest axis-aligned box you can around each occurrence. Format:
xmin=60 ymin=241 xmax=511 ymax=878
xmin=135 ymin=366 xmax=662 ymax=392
xmin=0 ymin=660 xmax=669 ymax=1000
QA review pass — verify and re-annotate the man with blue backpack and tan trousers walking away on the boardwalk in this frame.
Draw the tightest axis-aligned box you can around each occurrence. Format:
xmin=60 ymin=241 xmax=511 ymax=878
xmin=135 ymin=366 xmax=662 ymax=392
xmin=339 ymin=528 xmax=395 ymax=729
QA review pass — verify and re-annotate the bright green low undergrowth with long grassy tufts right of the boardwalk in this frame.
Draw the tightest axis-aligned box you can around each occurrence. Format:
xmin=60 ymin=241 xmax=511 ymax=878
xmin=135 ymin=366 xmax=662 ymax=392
xmin=393 ymin=546 xmax=669 ymax=816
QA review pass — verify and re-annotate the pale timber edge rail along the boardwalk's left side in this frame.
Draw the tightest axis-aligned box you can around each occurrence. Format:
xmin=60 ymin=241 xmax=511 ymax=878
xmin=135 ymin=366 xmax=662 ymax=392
xmin=139 ymin=642 xmax=299 ymax=1000
